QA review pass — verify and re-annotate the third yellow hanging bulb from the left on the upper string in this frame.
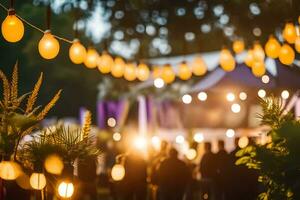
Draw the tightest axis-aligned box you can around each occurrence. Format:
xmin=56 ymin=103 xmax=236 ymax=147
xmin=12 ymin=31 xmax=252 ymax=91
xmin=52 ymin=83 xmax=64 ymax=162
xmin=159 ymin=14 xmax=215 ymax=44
xmin=69 ymin=39 xmax=86 ymax=64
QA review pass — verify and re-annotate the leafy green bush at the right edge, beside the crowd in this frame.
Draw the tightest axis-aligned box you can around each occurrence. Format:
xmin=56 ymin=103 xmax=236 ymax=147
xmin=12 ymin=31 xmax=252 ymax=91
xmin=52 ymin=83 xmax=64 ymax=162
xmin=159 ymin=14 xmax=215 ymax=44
xmin=236 ymin=97 xmax=300 ymax=200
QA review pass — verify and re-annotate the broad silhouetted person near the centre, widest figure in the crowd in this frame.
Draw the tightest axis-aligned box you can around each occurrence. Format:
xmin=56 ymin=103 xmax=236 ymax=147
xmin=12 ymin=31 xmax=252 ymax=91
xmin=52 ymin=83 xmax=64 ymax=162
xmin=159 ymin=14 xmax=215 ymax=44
xmin=158 ymin=148 xmax=190 ymax=200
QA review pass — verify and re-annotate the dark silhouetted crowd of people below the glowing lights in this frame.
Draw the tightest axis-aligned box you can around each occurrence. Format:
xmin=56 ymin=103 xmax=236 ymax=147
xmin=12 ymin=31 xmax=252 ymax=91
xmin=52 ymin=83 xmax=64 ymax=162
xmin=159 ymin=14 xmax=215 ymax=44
xmin=96 ymin=140 xmax=259 ymax=200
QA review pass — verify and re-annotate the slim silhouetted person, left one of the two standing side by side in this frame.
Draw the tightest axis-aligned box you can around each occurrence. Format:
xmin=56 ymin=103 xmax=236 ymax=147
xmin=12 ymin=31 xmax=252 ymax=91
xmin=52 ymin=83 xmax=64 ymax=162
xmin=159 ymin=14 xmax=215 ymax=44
xmin=200 ymin=142 xmax=217 ymax=199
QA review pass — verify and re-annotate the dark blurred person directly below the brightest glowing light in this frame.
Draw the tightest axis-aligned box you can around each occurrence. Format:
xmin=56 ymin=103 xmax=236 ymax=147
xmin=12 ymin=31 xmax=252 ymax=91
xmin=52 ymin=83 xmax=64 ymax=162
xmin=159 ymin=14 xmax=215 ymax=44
xmin=122 ymin=151 xmax=147 ymax=200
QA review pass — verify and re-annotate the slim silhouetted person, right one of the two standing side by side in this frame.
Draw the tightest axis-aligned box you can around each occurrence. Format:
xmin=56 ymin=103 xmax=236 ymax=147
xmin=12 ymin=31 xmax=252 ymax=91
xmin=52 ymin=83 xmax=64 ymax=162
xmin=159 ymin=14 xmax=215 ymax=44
xmin=215 ymin=140 xmax=231 ymax=200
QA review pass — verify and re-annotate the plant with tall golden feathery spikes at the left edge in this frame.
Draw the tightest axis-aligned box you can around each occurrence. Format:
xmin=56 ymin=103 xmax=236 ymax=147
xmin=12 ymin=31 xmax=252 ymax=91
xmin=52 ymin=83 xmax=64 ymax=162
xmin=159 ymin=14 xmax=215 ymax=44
xmin=0 ymin=63 xmax=61 ymax=159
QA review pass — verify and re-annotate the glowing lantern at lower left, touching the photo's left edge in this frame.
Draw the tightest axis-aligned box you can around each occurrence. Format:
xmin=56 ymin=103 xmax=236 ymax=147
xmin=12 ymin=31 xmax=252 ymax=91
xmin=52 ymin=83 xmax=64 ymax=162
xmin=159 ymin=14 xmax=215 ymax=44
xmin=0 ymin=161 xmax=21 ymax=180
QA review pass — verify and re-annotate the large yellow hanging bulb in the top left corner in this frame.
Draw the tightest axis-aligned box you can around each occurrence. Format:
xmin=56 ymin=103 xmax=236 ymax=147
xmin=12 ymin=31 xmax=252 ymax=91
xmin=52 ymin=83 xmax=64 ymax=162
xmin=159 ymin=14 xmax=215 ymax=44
xmin=1 ymin=9 xmax=24 ymax=42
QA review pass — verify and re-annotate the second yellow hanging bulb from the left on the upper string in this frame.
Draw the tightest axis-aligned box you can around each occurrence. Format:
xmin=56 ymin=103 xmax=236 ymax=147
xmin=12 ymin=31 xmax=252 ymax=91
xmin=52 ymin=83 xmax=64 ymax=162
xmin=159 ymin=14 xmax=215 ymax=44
xmin=38 ymin=30 xmax=60 ymax=59
